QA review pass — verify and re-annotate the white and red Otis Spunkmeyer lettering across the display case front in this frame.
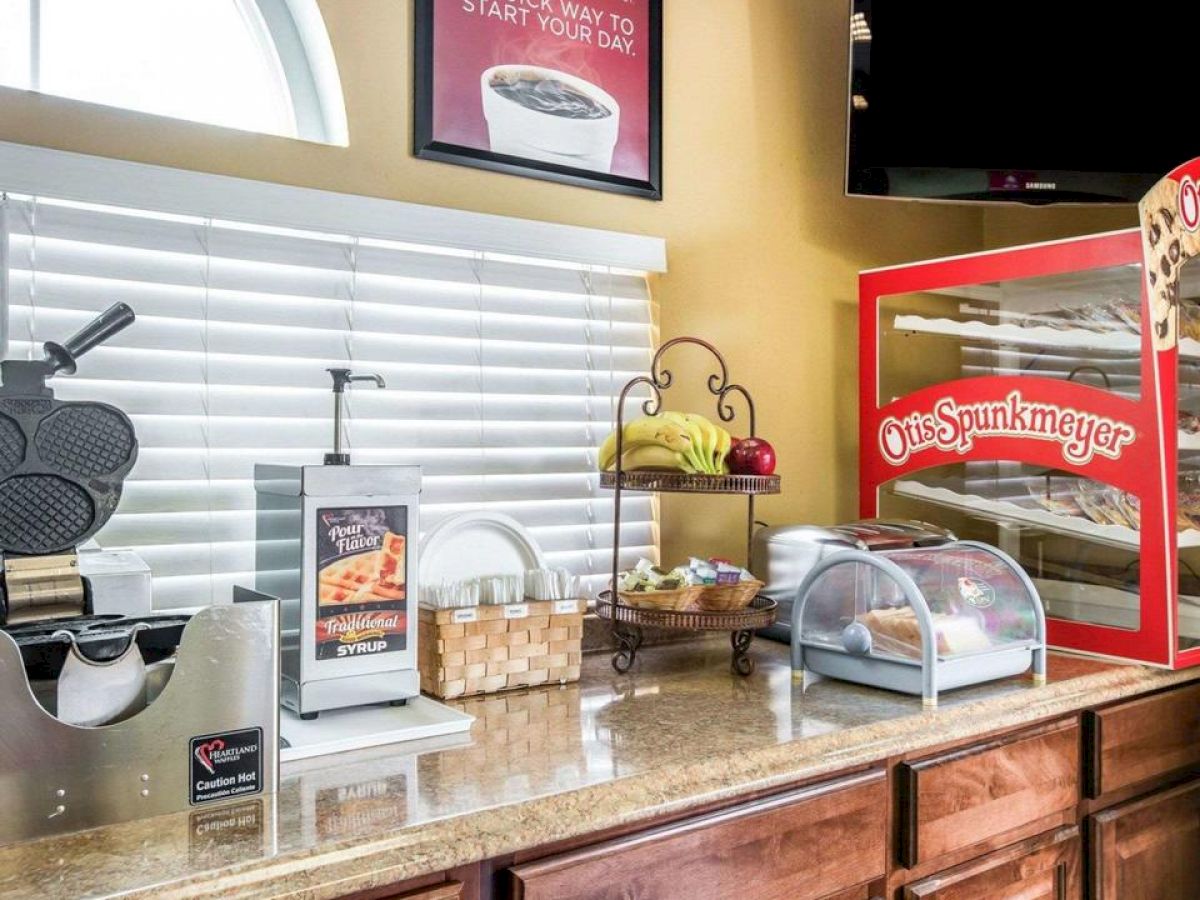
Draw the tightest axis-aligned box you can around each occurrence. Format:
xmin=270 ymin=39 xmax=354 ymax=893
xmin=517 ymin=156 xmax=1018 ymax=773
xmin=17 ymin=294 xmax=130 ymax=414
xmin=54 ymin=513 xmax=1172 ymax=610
xmin=878 ymin=391 xmax=1138 ymax=466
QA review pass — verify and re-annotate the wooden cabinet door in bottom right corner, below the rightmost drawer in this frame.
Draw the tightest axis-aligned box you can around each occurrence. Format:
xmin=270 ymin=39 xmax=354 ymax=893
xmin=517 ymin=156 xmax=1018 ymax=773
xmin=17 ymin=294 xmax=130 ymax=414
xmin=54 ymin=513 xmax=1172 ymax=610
xmin=1088 ymin=779 xmax=1200 ymax=900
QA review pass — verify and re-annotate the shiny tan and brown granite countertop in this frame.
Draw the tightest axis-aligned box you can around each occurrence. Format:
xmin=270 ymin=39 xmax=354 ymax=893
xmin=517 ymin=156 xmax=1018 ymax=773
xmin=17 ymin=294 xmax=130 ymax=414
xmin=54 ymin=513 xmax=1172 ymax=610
xmin=0 ymin=638 xmax=1200 ymax=898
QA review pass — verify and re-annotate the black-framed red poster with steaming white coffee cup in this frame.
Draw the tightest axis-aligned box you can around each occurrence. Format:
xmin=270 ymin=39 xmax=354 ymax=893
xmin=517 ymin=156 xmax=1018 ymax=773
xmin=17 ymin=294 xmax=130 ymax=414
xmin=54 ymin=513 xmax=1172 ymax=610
xmin=414 ymin=0 xmax=662 ymax=199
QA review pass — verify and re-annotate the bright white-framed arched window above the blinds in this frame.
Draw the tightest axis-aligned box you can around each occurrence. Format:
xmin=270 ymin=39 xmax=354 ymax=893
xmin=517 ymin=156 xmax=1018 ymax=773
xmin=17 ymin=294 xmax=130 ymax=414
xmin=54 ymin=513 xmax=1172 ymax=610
xmin=0 ymin=0 xmax=347 ymax=144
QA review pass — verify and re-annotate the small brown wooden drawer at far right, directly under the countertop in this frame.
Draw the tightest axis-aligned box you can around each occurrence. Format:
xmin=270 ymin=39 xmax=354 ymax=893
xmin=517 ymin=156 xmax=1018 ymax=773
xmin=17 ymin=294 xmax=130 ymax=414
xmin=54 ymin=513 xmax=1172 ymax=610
xmin=1084 ymin=684 xmax=1200 ymax=798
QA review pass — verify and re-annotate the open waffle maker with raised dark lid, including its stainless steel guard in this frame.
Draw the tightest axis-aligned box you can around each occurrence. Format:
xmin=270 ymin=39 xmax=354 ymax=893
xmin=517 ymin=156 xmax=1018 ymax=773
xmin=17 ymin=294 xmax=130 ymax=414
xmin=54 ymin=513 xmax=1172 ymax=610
xmin=0 ymin=304 xmax=280 ymax=846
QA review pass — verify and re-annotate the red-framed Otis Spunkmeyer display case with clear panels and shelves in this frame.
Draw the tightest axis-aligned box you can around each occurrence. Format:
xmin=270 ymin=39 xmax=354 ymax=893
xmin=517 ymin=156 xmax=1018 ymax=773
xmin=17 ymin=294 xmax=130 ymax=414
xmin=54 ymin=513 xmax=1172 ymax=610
xmin=859 ymin=160 xmax=1200 ymax=668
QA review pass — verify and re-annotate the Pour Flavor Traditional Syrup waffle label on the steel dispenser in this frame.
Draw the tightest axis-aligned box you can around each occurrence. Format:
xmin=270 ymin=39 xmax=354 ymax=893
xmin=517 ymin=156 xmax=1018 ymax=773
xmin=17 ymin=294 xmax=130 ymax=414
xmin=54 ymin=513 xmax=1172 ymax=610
xmin=316 ymin=506 xmax=408 ymax=660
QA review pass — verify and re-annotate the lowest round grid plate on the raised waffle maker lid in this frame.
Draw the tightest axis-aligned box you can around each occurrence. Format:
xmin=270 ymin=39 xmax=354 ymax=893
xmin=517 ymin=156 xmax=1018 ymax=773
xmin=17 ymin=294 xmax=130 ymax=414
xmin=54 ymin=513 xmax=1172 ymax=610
xmin=0 ymin=475 xmax=96 ymax=553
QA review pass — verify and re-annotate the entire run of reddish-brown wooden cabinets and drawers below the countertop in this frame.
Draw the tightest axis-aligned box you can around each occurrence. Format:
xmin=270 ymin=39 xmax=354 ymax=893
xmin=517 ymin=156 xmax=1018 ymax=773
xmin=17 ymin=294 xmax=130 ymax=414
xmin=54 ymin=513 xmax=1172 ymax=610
xmin=343 ymin=684 xmax=1200 ymax=900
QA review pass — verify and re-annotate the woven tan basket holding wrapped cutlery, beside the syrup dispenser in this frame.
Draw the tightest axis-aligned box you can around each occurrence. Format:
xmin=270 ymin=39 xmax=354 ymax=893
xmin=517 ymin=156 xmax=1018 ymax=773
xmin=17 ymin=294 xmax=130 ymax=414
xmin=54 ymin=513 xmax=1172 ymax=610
xmin=418 ymin=600 xmax=587 ymax=700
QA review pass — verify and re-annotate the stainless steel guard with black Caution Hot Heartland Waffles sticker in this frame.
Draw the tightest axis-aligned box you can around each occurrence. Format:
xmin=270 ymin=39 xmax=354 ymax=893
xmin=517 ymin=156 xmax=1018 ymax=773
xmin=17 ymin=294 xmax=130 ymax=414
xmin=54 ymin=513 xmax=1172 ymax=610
xmin=0 ymin=592 xmax=280 ymax=845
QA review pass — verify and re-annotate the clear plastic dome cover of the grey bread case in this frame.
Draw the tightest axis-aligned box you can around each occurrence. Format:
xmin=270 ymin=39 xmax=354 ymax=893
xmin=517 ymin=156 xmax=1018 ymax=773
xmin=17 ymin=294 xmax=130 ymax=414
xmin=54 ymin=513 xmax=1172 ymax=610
xmin=799 ymin=544 xmax=1040 ymax=659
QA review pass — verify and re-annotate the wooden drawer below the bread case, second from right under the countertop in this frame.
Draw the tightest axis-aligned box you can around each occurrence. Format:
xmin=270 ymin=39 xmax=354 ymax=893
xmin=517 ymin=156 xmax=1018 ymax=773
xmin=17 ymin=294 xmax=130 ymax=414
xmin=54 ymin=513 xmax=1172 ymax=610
xmin=896 ymin=720 xmax=1079 ymax=868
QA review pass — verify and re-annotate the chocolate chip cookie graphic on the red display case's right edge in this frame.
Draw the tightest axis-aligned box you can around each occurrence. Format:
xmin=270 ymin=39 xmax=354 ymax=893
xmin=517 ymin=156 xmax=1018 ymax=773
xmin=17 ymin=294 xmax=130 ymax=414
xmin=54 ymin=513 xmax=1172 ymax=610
xmin=1138 ymin=178 xmax=1200 ymax=350
